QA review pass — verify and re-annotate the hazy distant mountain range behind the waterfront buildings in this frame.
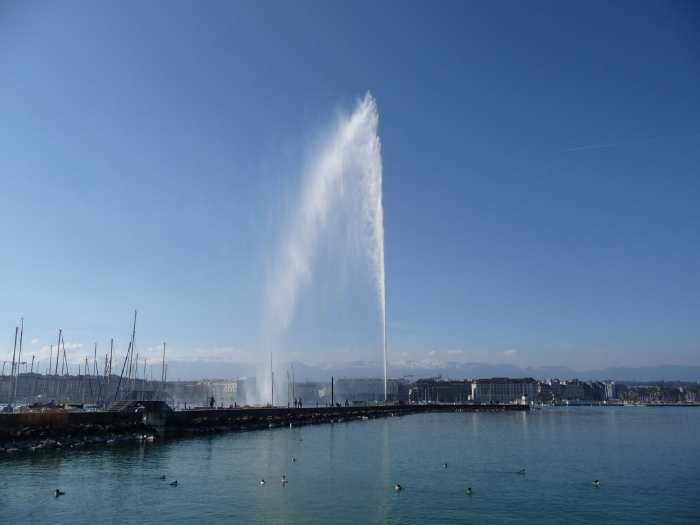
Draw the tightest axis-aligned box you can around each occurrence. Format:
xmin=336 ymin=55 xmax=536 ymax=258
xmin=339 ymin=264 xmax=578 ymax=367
xmin=161 ymin=360 xmax=700 ymax=382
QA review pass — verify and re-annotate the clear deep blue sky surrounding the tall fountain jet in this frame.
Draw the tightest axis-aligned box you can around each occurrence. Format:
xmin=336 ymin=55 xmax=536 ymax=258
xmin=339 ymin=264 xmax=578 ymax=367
xmin=0 ymin=1 xmax=700 ymax=369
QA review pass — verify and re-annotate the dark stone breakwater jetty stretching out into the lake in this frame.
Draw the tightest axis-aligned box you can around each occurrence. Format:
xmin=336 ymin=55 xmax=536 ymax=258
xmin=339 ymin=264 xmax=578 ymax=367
xmin=0 ymin=403 xmax=529 ymax=454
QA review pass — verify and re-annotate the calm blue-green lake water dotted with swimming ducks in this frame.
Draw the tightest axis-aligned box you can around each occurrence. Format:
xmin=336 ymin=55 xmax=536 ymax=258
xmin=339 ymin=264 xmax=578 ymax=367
xmin=0 ymin=407 xmax=700 ymax=524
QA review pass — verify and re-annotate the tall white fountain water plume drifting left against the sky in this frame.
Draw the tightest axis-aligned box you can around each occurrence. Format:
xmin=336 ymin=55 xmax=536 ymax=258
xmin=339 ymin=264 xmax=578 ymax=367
xmin=262 ymin=93 xmax=387 ymax=399
